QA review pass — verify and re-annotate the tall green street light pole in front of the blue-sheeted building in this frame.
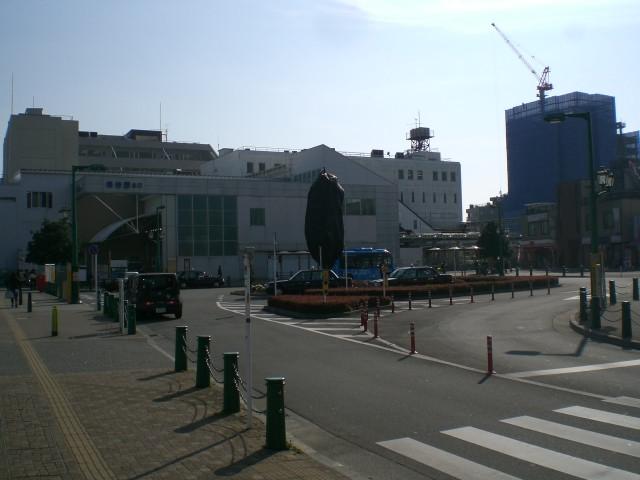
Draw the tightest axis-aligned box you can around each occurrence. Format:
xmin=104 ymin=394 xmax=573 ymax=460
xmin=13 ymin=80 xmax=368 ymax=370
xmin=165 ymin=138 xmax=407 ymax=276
xmin=544 ymin=112 xmax=604 ymax=328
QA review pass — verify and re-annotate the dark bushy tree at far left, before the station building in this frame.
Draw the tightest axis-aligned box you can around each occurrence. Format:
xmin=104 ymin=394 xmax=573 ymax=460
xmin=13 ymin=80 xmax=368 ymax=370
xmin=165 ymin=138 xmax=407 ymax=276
xmin=27 ymin=219 xmax=72 ymax=265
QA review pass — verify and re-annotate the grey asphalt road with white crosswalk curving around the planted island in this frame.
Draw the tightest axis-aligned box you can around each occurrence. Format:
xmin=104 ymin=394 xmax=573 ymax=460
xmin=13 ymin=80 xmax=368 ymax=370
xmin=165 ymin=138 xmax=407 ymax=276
xmin=114 ymin=278 xmax=640 ymax=479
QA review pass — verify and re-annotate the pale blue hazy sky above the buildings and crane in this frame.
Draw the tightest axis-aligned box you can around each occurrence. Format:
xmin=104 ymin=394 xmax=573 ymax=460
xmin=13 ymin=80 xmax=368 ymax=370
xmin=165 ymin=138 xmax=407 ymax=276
xmin=0 ymin=0 xmax=640 ymax=218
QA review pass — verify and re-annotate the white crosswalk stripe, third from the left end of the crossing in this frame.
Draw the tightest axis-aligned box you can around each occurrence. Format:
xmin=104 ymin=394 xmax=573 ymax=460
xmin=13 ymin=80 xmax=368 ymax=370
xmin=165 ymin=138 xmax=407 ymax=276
xmin=501 ymin=415 xmax=640 ymax=457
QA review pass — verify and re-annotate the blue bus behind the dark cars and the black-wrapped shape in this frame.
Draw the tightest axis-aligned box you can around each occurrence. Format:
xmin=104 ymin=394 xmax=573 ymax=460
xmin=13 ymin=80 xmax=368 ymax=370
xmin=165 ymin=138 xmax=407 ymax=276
xmin=332 ymin=247 xmax=394 ymax=280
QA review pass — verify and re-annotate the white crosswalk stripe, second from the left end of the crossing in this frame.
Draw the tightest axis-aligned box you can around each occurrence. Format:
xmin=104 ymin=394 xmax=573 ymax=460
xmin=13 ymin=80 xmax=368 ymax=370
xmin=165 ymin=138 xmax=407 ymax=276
xmin=442 ymin=427 xmax=640 ymax=480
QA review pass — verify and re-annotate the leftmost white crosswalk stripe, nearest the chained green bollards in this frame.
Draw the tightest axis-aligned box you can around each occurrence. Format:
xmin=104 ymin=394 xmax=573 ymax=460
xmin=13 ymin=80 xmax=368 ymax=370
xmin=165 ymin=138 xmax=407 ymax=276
xmin=378 ymin=438 xmax=518 ymax=480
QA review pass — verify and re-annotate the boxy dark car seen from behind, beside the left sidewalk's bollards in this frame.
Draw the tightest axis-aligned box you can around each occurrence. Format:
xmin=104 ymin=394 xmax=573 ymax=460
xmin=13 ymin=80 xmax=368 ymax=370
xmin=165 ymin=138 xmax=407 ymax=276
xmin=125 ymin=273 xmax=182 ymax=318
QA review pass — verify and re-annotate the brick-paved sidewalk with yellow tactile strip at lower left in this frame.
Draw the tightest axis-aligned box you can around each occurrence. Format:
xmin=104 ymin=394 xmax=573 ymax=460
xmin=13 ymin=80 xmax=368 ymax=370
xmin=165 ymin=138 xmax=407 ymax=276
xmin=0 ymin=294 xmax=346 ymax=479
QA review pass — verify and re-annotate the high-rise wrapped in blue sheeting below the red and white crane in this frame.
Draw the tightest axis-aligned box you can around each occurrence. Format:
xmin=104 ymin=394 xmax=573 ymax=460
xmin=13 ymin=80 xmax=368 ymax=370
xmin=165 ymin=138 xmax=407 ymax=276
xmin=504 ymin=92 xmax=616 ymax=218
